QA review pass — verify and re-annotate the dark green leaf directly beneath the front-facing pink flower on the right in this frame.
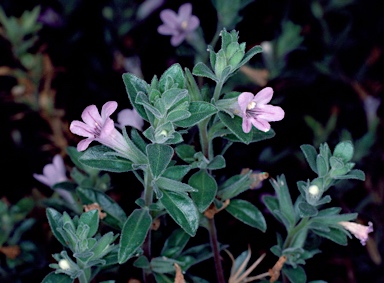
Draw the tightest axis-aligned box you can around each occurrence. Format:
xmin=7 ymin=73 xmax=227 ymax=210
xmin=218 ymin=112 xmax=275 ymax=144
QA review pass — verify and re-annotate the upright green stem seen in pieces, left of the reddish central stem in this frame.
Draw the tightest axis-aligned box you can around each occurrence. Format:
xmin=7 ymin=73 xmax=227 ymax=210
xmin=142 ymin=170 xmax=154 ymax=283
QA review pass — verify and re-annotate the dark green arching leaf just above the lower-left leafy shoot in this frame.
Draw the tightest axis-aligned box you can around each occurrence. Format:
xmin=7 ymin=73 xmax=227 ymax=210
xmin=76 ymin=187 xmax=127 ymax=230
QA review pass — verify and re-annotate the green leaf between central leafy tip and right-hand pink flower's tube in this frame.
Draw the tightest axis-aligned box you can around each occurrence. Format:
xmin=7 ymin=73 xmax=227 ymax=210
xmin=174 ymin=101 xmax=217 ymax=128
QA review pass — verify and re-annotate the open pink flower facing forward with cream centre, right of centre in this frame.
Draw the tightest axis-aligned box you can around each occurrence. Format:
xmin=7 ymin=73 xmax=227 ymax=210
xmin=237 ymin=87 xmax=285 ymax=133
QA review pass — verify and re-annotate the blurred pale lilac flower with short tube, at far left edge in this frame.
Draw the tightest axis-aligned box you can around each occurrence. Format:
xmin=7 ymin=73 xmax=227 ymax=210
xmin=33 ymin=154 xmax=75 ymax=204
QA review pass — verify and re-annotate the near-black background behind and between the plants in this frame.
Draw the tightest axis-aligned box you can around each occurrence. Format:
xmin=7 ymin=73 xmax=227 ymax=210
xmin=0 ymin=0 xmax=384 ymax=283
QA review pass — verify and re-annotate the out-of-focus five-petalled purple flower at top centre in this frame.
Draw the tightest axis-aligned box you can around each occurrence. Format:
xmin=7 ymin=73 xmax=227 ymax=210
xmin=157 ymin=3 xmax=200 ymax=46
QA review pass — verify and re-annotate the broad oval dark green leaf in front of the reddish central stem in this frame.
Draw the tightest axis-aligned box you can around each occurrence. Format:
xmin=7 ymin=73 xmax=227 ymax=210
xmin=188 ymin=170 xmax=217 ymax=213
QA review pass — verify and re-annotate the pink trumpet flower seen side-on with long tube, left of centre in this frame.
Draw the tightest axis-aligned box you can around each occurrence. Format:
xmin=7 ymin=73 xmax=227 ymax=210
xmin=69 ymin=101 xmax=130 ymax=158
